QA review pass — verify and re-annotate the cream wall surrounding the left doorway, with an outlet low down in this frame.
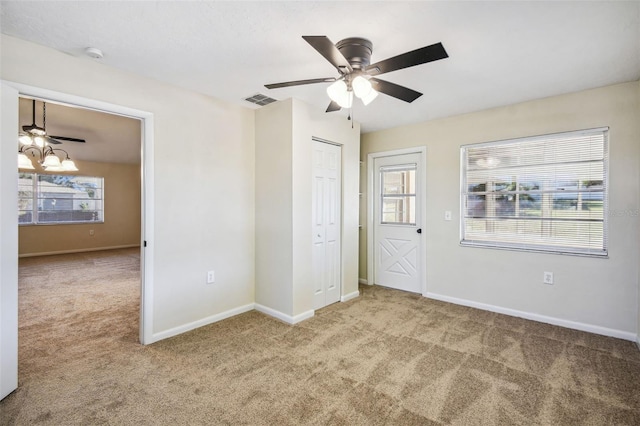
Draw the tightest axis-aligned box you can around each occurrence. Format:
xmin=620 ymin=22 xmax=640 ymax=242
xmin=1 ymin=35 xmax=255 ymax=341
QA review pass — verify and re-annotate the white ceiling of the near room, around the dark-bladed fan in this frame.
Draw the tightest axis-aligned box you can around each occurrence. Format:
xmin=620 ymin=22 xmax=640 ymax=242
xmin=1 ymin=1 xmax=640 ymax=132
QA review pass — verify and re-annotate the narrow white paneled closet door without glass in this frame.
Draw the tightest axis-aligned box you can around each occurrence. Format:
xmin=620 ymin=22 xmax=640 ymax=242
xmin=312 ymin=141 xmax=342 ymax=309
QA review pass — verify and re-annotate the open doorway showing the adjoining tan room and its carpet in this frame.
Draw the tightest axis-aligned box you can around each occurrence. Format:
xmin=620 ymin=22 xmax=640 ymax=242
xmin=18 ymin=96 xmax=142 ymax=372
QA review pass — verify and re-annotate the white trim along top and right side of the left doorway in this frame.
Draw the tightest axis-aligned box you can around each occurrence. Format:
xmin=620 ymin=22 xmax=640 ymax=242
xmin=2 ymin=80 xmax=154 ymax=345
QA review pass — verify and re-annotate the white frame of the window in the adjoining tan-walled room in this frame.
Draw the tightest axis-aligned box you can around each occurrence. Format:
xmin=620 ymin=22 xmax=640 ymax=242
xmin=18 ymin=171 xmax=105 ymax=226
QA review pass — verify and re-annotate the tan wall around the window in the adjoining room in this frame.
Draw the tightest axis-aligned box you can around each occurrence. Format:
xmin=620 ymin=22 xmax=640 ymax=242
xmin=19 ymin=161 xmax=141 ymax=256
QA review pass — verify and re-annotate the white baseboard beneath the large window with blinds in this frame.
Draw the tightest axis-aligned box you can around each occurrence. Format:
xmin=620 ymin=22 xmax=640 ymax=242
xmin=425 ymin=293 xmax=638 ymax=342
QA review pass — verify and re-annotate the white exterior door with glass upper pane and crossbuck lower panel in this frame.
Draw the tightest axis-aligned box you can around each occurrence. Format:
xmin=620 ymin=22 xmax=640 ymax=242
xmin=373 ymin=153 xmax=423 ymax=293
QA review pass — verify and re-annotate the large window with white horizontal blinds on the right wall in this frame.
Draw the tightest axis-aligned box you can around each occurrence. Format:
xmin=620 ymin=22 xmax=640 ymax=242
xmin=461 ymin=128 xmax=608 ymax=256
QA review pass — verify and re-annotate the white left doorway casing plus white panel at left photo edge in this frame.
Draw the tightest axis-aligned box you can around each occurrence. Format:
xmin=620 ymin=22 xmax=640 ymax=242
xmin=0 ymin=80 xmax=154 ymax=395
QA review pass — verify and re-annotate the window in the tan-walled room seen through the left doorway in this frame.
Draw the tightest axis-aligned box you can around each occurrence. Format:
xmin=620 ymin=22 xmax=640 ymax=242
xmin=18 ymin=173 xmax=104 ymax=224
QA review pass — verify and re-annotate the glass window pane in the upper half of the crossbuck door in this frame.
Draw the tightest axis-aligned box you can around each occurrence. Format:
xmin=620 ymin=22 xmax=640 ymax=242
xmin=380 ymin=164 xmax=416 ymax=225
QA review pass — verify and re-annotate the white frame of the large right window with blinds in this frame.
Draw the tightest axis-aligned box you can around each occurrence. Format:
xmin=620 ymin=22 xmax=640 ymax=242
xmin=460 ymin=127 xmax=610 ymax=259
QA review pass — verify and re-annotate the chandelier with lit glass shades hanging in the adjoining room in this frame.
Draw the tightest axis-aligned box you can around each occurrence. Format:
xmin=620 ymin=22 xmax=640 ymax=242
xmin=18 ymin=99 xmax=78 ymax=172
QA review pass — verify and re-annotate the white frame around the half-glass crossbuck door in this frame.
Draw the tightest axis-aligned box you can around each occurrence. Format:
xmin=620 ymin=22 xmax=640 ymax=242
xmin=367 ymin=146 xmax=427 ymax=297
